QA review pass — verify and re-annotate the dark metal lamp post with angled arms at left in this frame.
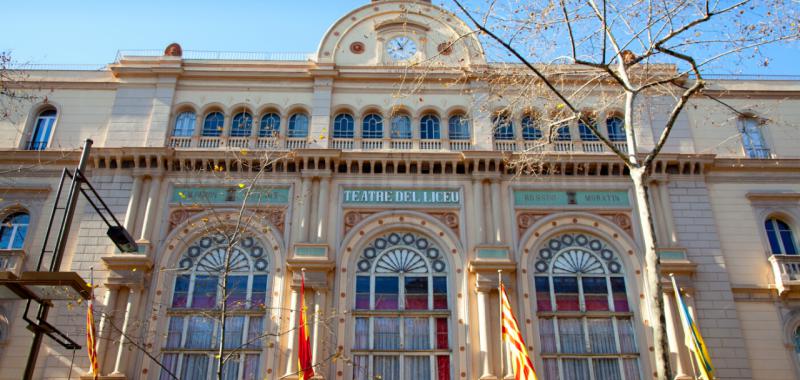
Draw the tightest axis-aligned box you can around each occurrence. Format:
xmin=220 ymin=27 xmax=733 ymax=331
xmin=0 ymin=139 xmax=138 ymax=380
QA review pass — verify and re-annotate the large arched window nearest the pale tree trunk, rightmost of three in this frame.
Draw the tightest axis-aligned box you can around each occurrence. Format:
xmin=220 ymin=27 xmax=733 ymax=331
xmin=534 ymin=233 xmax=641 ymax=380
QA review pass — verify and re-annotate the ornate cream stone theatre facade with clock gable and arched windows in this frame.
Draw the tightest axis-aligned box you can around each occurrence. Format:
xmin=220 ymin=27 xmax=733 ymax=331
xmin=0 ymin=1 xmax=800 ymax=380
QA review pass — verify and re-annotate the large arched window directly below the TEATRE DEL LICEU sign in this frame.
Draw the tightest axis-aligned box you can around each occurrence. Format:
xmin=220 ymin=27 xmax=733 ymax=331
xmin=351 ymin=232 xmax=452 ymax=380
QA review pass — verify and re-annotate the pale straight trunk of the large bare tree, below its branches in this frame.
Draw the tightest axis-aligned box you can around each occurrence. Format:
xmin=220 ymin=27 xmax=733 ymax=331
xmin=630 ymin=168 xmax=672 ymax=379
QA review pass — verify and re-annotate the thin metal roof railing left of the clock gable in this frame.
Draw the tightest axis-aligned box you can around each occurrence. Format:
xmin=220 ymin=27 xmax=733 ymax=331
xmin=116 ymin=50 xmax=316 ymax=62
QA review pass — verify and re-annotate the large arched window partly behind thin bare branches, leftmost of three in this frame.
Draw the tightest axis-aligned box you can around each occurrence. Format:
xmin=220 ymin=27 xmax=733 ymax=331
xmin=162 ymin=235 xmax=270 ymax=380
